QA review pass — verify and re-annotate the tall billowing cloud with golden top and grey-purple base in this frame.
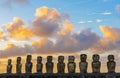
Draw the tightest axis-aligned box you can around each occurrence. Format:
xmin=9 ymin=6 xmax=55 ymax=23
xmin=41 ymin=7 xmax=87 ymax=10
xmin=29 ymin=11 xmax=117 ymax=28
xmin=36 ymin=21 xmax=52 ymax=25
xmin=33 ymin=7 xmax=60 ymax=37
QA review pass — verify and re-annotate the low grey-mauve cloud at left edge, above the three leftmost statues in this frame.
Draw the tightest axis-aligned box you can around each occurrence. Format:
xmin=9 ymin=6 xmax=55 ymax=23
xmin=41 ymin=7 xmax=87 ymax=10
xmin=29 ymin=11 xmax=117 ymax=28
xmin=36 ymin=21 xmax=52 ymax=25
xmin=0 ymin=43 xmax=33 ymax=58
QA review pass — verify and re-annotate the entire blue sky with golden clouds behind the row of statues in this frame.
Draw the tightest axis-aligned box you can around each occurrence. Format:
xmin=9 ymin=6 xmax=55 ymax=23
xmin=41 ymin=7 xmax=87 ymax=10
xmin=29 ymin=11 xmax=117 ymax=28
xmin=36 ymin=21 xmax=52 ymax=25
xmin=0 ymin=0 xmax=120 ymax=73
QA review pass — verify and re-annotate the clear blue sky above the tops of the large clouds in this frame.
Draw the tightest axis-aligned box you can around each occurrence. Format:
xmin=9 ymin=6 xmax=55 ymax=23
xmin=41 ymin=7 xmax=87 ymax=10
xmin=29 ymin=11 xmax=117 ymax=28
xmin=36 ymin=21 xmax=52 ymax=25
xmin=0 ymin=0 xmax=120 ymax=34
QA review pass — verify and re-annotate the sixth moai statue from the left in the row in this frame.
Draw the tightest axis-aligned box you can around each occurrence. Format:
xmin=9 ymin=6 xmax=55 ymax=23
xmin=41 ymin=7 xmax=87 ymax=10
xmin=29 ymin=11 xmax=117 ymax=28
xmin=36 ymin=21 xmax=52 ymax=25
xmin=57 ymin=56 xmax=65 ymax=73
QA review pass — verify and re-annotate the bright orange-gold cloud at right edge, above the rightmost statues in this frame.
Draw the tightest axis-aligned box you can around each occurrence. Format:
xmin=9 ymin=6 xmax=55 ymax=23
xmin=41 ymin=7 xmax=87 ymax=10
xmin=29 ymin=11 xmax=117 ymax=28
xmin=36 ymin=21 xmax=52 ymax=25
xmin=90 ymin=26 xmax=120 ymax=53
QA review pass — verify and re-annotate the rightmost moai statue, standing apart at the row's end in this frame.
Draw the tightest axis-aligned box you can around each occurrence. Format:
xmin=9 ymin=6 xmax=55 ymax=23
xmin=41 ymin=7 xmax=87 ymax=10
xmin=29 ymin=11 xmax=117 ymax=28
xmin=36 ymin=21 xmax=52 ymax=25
xmin=107 ymin=55 xmax=116 ymax=73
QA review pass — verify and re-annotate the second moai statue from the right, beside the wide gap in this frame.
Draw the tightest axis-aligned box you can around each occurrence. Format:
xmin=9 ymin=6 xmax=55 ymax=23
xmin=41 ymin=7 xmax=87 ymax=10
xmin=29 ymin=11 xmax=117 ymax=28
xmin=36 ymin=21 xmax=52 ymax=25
xmin=92 ymin=54 xmax=101 ymax=73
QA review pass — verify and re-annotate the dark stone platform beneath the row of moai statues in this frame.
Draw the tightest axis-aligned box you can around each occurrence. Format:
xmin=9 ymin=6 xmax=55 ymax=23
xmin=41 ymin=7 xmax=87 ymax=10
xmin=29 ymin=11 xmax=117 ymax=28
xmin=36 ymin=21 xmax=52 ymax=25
xmin=0 ymin=73 xmax=120 ymax=78
